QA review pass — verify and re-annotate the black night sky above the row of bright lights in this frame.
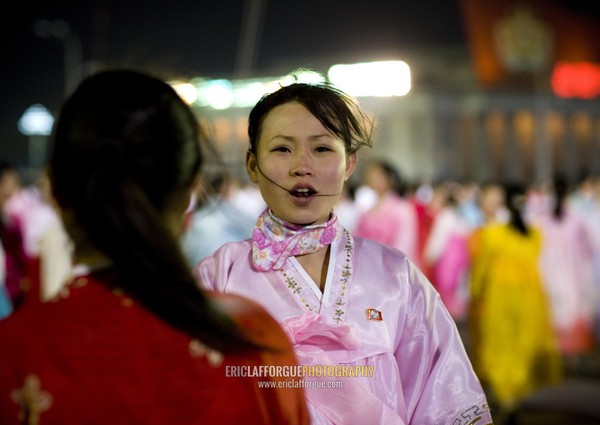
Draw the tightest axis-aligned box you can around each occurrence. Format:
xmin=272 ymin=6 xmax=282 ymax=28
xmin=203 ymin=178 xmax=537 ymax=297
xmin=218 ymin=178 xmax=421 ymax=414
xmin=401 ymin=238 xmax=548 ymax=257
xmin=0 ymin=0 xmax=465 ymax=166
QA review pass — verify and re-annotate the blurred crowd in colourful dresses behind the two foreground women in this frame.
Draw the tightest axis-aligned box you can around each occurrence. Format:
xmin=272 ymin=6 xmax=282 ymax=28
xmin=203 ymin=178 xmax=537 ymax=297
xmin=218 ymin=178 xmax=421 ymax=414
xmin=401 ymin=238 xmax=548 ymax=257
xmin=0 ymin=158 xmax=600 ymax=423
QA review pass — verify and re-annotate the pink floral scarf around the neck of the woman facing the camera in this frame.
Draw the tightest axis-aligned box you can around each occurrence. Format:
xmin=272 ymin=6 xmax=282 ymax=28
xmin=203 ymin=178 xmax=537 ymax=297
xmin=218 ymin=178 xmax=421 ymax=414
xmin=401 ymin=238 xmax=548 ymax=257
xmin=252 ymin=208 xmax=340 ymax=272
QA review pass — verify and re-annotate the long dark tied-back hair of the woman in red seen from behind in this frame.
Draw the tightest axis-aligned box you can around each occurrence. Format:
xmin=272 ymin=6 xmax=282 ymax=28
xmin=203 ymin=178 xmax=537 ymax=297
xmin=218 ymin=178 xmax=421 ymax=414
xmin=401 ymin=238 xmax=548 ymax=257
xmin=50 ymin=71 xmax=254 ymax=349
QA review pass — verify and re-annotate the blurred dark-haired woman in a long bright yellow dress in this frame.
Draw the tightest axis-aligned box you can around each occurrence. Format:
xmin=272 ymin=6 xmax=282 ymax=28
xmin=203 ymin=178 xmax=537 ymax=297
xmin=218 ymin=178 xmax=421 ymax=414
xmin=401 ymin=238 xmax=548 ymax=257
xmin=471 ymin=186 xmax=562 ymax=411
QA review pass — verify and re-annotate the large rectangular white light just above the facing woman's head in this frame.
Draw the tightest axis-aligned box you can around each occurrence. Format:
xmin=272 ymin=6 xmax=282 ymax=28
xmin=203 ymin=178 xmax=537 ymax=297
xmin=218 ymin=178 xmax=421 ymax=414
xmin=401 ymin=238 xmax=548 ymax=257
xmin=328 ymin=61 xmax=411 ymax=97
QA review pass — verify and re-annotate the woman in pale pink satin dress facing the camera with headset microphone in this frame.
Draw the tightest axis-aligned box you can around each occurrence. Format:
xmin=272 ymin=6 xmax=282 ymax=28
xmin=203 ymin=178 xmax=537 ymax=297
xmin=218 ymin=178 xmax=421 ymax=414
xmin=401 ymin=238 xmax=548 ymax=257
xmin=195 ymin=79 xmax=491 ymax=425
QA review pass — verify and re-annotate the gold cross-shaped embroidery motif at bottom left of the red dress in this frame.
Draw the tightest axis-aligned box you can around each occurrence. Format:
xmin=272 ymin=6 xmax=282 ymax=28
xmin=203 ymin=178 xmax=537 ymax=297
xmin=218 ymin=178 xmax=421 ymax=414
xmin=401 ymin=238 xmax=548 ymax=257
xmin=10 ymin=373 xmax=53 ymax=425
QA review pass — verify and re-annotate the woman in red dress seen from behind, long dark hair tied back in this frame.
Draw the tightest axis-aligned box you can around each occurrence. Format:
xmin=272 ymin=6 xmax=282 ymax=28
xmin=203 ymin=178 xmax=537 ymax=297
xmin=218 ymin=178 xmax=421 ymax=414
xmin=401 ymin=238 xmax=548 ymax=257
xmin=0 ymin=71 xmax=308 ymax=425
